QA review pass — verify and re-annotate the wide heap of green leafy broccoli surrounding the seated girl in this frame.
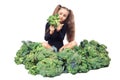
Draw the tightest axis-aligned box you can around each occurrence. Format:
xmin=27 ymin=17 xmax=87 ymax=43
xmin=14 ymin=40 xmax=111 ymax=77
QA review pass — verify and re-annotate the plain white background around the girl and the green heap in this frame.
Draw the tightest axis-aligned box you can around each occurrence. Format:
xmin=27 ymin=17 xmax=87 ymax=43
xmin=0 ymin=0 xmax=120 ymax=80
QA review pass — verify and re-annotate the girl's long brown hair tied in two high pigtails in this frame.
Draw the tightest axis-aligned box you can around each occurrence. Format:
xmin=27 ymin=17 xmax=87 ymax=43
xmin=53 ymin=5 xmax=75 ymax=42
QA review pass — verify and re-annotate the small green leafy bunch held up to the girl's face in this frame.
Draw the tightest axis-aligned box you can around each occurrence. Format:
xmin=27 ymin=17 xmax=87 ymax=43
xmin=47 ymin=14 xmax=60 ymax=28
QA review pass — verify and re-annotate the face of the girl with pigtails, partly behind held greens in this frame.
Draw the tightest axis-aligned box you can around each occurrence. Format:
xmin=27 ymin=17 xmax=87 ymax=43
xmin=58 ymin=8 xmax=69 ymax=22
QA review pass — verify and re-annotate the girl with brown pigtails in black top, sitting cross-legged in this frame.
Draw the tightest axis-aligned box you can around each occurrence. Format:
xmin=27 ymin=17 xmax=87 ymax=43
xmin=42 ymin=5 xmax=77 ymax=52
